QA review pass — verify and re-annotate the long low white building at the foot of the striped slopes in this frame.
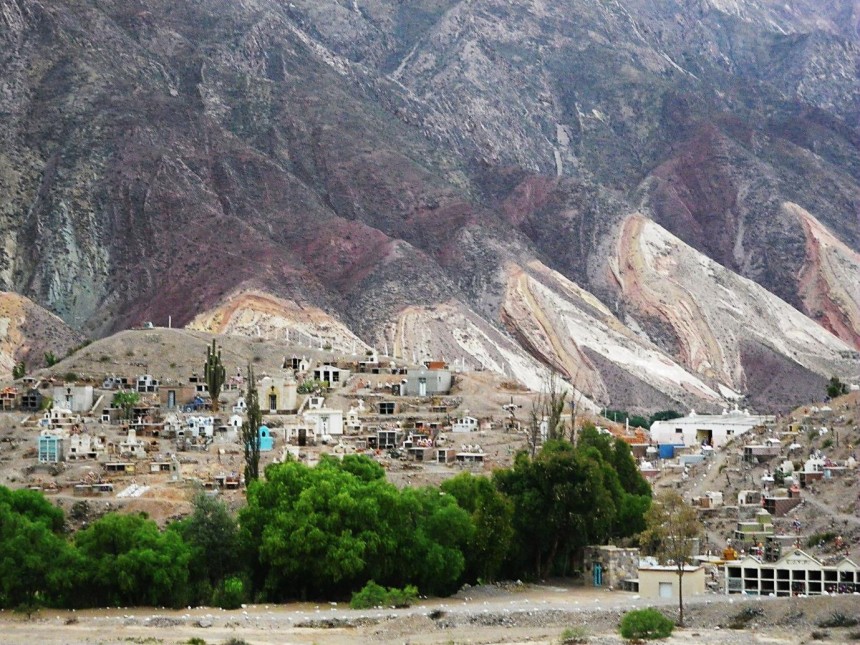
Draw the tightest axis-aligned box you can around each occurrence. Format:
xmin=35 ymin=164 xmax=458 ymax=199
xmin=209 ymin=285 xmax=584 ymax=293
xmin=650 ymin=409 xmax=774 ymax=448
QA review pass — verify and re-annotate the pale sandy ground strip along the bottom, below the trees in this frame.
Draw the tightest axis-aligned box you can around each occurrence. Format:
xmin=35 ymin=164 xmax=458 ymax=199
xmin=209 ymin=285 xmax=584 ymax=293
xmin=0 ymin=585 xmax=860 ymax=645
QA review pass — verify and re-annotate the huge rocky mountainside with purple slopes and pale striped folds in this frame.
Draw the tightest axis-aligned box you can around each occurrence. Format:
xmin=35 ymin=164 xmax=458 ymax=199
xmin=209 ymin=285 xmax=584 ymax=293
xmin=0 ymin=0 xmax=860 ymax=410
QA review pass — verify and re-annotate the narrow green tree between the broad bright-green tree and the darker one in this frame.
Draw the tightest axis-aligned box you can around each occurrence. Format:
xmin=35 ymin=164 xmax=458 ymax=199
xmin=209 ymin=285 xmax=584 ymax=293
xmin=441 ymin=472 xmax=514 ymax=582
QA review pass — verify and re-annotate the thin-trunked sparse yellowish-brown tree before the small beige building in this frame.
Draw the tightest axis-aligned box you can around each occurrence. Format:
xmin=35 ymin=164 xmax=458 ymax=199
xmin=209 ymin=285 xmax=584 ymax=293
xmin=643 ymin=491 xmax=703 ymax=627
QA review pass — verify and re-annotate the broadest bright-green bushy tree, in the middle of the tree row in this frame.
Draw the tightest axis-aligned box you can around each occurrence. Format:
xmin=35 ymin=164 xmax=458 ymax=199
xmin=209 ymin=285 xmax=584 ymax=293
xmin=239 ymin=457 xmax=474 ymax=600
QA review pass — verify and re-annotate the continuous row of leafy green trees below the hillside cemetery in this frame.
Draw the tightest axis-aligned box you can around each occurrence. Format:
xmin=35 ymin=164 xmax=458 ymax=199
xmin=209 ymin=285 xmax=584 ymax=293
xmin=0 ymin=427 xmax=650 ymax=607
